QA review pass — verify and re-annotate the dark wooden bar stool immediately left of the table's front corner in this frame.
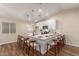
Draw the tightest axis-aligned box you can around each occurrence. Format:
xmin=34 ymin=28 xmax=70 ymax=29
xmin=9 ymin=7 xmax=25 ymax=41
xmin=29 ymin=40 xmax=41 ymax=55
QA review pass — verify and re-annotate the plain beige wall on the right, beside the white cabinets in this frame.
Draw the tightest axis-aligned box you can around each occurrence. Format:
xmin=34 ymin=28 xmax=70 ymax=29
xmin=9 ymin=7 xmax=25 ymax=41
xmin=52 ymin=8 xmax=79 ymax=47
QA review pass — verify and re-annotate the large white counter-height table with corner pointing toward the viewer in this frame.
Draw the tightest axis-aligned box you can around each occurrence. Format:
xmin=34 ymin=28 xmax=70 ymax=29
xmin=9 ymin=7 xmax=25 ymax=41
xmin=29 ymin=34 xmax=59 ymax=54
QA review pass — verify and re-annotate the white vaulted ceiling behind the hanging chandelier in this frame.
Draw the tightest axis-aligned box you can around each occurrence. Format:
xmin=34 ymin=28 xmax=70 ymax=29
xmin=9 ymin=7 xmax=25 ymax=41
xmin=0 ymin=3 xmax=79 ymax=23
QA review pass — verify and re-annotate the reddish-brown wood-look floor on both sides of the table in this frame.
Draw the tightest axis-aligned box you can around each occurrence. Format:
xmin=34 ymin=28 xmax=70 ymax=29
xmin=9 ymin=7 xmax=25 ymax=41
xmin=0 ymin=42 xmax=79 ymax=56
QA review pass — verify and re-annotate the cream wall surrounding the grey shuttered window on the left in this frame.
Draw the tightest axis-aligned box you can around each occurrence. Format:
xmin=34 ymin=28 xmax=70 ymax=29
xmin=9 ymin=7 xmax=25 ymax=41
xmin=0 ymin=18 xmax=30 ymax=45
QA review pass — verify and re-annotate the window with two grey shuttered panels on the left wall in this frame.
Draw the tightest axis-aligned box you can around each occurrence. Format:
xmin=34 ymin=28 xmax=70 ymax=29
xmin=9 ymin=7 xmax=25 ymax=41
xmin=2 ymin=22 xmax=16 ymax=33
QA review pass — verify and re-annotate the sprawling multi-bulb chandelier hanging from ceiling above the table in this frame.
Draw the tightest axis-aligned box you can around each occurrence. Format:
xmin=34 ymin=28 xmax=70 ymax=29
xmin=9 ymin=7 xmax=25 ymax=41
xmin=26 ymin=3 xmax=48 ymax=23
